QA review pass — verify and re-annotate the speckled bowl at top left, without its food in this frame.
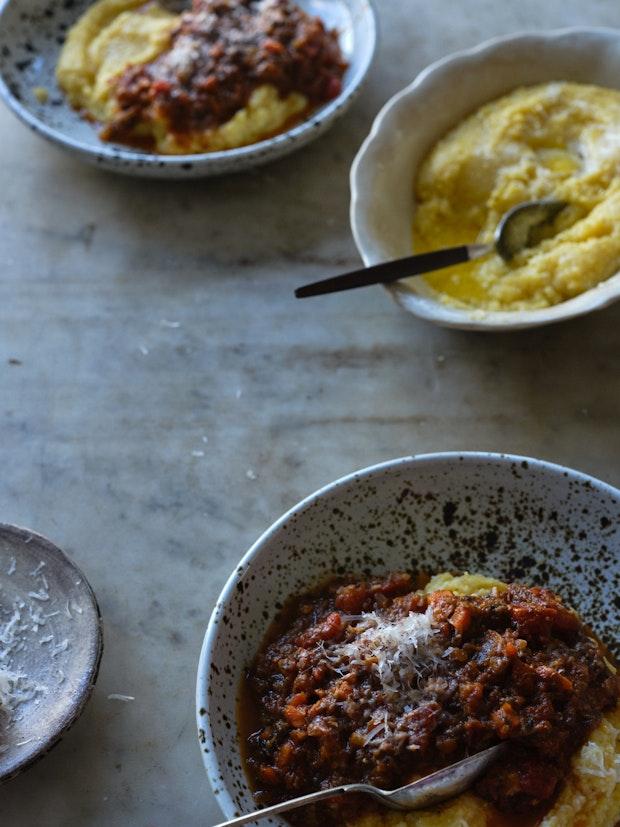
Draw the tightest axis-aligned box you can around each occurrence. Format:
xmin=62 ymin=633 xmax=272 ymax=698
xmin=0 ymin=0 xmax=377 ymax=178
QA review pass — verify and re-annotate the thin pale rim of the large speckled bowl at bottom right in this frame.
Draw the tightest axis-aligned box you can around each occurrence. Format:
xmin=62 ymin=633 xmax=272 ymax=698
xmin=195 ymin=451 xmax=620 ymax=818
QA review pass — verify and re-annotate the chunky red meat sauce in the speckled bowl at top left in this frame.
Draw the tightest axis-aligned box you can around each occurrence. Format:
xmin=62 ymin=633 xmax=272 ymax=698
xmin=102 ymin=0 xmax=346 ymax=142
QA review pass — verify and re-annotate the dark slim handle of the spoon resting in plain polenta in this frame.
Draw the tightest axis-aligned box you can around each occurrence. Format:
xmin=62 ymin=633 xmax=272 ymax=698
xmin=295 ymin=244 xmax=491 ymax=299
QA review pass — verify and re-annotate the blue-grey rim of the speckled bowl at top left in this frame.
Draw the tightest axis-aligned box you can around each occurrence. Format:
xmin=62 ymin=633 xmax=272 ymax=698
xmin=0 ymin=0 xmax=378 ymax=173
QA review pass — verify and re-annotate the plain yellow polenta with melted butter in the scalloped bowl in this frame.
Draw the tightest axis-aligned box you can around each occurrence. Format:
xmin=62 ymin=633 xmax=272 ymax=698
xmin=412 ymin=83 xmax=620 ymax=310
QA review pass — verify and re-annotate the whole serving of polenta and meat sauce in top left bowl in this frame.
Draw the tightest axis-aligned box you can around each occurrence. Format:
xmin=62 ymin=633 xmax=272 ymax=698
xmin=56 ymin=0 xmax=346 ymax=154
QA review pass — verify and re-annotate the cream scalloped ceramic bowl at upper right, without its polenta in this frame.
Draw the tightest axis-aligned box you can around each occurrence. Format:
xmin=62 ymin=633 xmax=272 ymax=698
xmin=351 ymin=28 xmax=620 ymax=330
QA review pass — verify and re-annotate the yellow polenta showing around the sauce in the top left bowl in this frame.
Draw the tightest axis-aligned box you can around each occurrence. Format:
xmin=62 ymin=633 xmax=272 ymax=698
xmin=56 ymin=0 xmax=308 ymax=154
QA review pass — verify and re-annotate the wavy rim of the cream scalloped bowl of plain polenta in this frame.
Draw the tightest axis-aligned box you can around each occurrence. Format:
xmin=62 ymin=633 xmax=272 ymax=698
xmin=349 ymin=26 xmax=620 ymax=331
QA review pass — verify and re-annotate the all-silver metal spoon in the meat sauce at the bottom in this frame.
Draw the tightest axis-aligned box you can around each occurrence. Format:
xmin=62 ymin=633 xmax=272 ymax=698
xmin=215 ymin=744 xmax=506 ymax=827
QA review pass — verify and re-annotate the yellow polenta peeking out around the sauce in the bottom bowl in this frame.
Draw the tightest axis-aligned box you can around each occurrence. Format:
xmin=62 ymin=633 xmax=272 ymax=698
xmin=346 ymin=572 xmax=620 ymax=827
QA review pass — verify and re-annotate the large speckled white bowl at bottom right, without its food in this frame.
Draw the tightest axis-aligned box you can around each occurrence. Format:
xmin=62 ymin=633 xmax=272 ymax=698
xmin=197 ymin=453 xmax=620 ymax=827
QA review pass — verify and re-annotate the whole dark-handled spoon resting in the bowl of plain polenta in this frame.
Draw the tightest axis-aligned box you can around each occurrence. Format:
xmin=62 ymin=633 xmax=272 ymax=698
xmin=295 ymin=200 xmax=566 ymax=299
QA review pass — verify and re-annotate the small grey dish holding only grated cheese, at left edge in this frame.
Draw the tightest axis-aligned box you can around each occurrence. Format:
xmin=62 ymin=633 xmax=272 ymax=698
xmin=0 ymin=524 xmax=103 ymax=780
